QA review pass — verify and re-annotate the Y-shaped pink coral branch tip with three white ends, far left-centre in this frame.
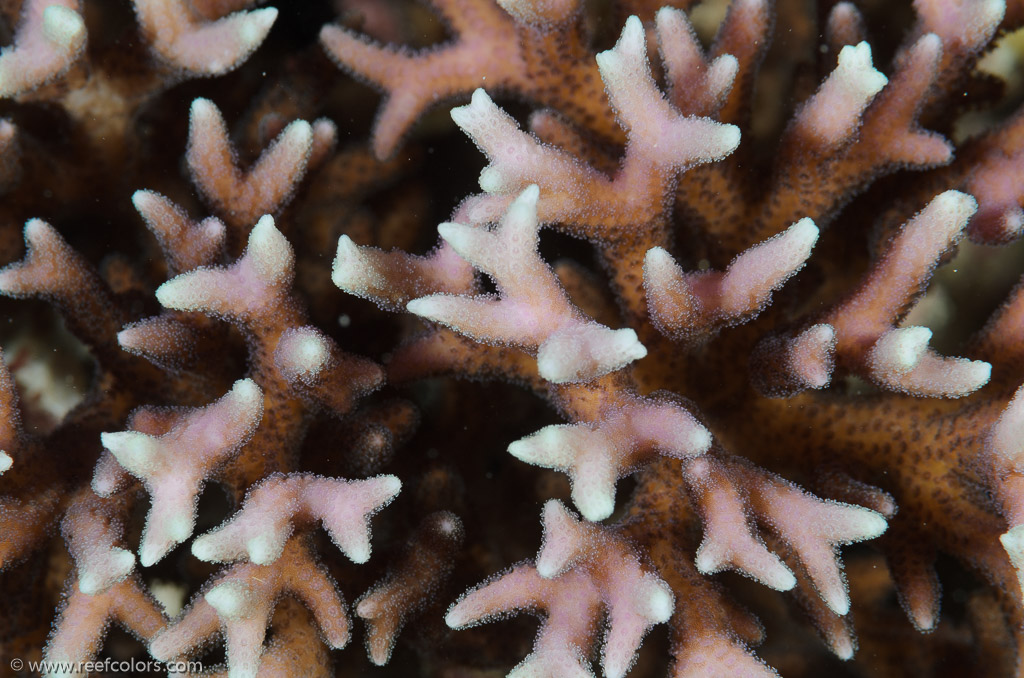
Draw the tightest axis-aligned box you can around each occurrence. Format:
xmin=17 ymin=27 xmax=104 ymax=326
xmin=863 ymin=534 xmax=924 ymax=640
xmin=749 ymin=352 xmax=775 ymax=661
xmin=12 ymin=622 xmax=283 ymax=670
xmin=100 ymin=379 xmax=263 ymax=567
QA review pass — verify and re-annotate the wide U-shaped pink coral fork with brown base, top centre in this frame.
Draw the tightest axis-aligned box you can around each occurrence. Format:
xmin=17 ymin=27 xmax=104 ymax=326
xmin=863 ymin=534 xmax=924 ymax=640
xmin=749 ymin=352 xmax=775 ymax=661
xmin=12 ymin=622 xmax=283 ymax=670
xmin=452 ymin=16 xmax=739 ymax=233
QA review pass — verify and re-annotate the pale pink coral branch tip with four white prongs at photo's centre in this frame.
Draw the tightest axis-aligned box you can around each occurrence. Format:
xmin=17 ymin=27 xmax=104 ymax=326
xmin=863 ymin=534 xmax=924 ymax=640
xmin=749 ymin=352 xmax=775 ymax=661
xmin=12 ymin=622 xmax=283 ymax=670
xmin=408 ymin=185 xmax=647 ymax=383
